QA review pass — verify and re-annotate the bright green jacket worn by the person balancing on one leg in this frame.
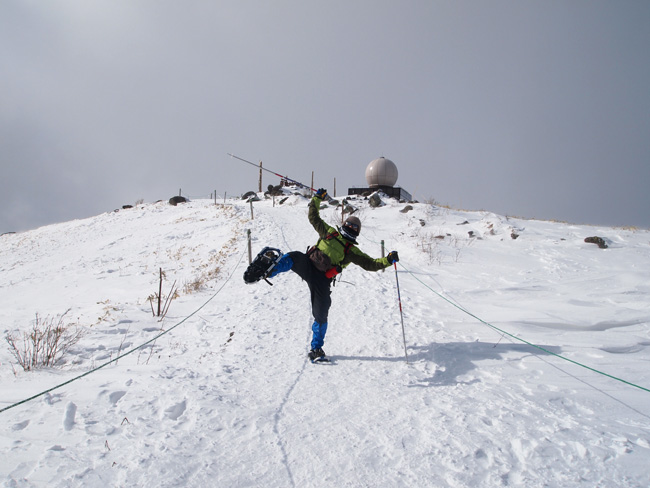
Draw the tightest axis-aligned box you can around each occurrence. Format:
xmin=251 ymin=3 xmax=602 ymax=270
xmin=308 ymin=197 xmax=390 ymax=271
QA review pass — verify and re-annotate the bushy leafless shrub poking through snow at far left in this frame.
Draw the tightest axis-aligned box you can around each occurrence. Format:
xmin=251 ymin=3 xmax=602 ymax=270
xmin=5 ymin=309 xmax=84 ymax=371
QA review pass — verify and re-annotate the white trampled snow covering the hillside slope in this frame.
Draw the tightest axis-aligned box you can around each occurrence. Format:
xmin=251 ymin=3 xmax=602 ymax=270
xmin=0 ymin=195 xmax=650 ymax=488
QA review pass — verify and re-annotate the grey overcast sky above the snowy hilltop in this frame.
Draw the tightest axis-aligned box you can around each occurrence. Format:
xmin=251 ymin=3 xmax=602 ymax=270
xmin=0 ymin=0 xmax=650 ymax=234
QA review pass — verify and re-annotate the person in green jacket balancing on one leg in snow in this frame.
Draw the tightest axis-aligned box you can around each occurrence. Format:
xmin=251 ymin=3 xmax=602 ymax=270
xmin=269 ymin=188 xmax=399 ymax=361
